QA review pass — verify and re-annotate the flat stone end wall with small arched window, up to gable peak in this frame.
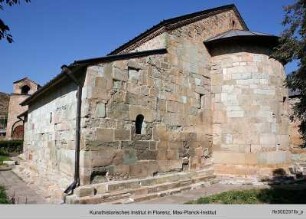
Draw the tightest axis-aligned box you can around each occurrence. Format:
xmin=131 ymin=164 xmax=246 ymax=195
xmin=76 ymin=9 xmax=246 ymax=184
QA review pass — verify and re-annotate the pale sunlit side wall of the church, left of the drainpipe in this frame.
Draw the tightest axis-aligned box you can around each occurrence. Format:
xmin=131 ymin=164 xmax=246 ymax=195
xmin=24 ymin=78 xmax=87 ymax=189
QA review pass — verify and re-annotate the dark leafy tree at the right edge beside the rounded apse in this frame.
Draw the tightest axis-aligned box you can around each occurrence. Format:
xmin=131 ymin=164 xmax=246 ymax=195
xmin=274 ymin=0 xmax=306 ymax=147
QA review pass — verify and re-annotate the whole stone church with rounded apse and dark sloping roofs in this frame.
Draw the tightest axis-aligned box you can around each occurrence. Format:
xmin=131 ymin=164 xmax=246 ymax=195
xmin=22 ymin=5 xmax=290 ymax=203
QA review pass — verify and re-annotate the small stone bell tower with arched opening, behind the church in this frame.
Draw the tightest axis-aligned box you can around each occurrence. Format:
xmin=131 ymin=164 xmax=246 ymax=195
xmin=6 ymin=78 xmax=40 ymax=139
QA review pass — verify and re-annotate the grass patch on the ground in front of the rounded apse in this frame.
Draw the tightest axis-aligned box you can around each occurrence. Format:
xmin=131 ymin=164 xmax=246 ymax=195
xmin=187 ymin=187 xmax=306 ymax=204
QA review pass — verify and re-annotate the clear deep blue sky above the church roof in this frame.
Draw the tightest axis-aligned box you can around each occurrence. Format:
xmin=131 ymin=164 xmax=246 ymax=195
xmin=0 ymin=0 xmax=294 ymax=93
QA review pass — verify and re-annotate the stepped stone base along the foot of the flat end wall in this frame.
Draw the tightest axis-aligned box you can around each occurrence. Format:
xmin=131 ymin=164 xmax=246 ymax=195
xmin=66 ymin=167 xmax=215 ymax=204
